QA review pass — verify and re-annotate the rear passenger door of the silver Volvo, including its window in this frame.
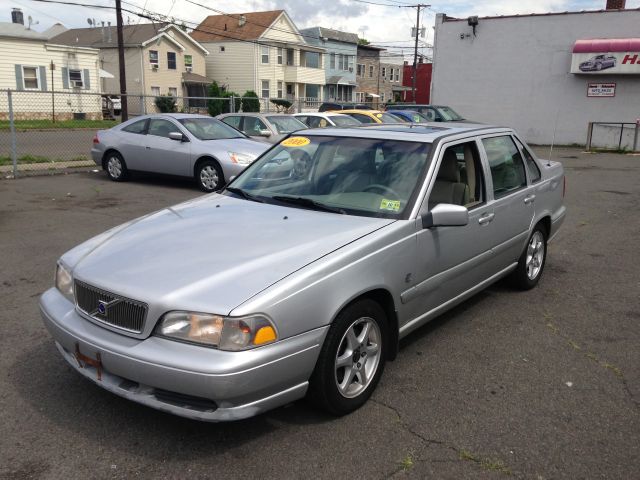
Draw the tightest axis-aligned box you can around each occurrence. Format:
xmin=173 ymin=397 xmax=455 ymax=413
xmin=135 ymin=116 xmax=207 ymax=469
xmin=480 ymin=134 xmax=535 ymax=267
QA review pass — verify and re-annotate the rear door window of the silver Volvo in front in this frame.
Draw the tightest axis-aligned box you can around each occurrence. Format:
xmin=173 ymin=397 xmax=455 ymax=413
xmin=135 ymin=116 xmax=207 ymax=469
xmin=482 ymin=135 xmax=527 ymax=198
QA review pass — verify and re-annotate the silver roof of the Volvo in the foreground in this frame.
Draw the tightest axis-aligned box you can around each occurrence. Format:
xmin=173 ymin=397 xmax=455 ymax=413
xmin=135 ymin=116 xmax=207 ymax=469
xmin=295 ymin=122 xmax=513 ymax=143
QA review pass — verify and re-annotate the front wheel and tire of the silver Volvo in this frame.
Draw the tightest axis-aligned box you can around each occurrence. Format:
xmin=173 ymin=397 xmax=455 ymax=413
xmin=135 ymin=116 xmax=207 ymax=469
xmin=307 ymin=299 xmax=388 ymax=415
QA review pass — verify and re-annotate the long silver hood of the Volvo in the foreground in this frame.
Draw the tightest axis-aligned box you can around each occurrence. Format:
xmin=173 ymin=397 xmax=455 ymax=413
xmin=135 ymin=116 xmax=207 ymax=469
xmin=62 ymin=194 xmax=393 ymax=314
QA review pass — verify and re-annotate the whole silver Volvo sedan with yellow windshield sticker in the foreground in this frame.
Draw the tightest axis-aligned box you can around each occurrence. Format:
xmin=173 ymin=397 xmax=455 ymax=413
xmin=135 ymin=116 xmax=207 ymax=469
xmin=40 ymin=125 xmax=565 ymax=421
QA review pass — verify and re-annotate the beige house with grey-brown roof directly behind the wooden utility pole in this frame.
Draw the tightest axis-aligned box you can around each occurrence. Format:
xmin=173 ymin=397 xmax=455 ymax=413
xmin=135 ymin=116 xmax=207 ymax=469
xmin=52 ymin=23 xmax=211 ymax=114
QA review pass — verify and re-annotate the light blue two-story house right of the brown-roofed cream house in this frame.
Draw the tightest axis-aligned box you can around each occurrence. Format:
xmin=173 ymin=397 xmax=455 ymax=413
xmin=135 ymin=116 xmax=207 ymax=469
xmin=300 ymin=27 xmax=358 ymax=102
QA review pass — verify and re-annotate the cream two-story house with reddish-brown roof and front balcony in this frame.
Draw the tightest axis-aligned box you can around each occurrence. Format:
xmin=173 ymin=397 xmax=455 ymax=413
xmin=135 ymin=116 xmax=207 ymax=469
xmin=191 ymin=10 xmax=325 ymax=106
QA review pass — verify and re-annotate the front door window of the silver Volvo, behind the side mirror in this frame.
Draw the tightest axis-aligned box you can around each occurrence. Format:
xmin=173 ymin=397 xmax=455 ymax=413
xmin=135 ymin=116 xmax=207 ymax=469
xmin=429 ymin=142 xmax=485 ymax=209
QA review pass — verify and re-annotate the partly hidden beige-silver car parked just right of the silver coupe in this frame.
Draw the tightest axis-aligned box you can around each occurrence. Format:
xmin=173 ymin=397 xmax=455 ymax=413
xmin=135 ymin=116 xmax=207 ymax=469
xmin=216 ymin=113 xmax=307 ymax=143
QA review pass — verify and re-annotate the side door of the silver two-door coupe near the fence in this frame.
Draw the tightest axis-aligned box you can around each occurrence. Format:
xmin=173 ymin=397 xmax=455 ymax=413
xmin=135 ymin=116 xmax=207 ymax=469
xmin=145 ymin=118 xmax=192 ymax=176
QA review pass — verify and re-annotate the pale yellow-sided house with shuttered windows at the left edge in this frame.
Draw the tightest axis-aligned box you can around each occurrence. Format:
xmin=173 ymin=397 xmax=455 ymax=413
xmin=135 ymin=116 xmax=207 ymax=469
xmin=0 ymin=9 xmax=102 ymax=120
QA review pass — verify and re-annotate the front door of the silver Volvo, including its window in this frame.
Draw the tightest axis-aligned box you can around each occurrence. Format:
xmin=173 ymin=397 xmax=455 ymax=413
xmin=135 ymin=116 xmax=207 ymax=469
xmin=405 ymin=140 xmax=498 ymax=318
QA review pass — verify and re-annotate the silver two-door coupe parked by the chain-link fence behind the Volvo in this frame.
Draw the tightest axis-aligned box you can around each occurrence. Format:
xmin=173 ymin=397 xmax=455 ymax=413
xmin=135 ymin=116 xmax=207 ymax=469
xmin=91 ymin=113 xmax=268 ymax=192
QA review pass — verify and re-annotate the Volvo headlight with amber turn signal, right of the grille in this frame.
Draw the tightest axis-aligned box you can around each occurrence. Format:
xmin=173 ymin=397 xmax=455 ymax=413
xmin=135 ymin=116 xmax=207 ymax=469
xmin=155 ymin=312 xmax=278 ymax=351
